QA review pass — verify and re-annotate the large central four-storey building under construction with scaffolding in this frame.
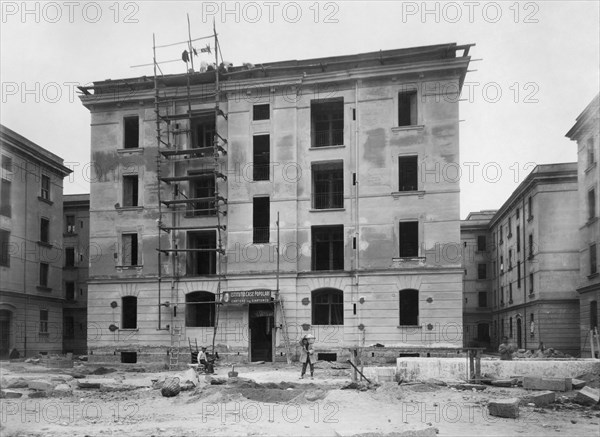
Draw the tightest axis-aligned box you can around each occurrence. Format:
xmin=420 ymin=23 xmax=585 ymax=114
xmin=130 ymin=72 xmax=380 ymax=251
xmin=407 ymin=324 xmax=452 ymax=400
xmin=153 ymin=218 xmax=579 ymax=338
xmin=81 ymin=44 xmax=470 ymax=362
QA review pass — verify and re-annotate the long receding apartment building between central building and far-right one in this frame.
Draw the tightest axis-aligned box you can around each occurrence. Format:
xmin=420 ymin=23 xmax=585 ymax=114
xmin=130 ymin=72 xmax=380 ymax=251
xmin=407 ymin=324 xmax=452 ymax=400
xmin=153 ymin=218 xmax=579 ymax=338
xmin=461 ymin=163 xmax=580 ymax=356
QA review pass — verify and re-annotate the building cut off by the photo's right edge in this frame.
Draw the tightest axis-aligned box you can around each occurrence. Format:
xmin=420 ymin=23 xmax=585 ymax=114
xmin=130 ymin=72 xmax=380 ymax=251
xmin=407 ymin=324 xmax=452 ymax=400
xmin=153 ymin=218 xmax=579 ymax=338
xmin=566 ymin=95 xmax=600 ymax=358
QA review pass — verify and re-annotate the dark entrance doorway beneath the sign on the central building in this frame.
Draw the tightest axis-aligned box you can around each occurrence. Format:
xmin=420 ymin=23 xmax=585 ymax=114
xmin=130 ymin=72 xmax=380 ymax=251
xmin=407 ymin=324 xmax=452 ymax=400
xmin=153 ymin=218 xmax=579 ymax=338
xmin=248 ymin=303 xmax=274 ymax=361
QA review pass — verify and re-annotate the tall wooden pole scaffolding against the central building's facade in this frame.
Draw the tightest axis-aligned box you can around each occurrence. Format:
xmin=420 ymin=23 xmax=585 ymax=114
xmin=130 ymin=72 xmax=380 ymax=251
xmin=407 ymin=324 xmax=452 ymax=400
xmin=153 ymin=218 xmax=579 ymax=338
xmin=152 ymin=16 xmax=227 ymax=367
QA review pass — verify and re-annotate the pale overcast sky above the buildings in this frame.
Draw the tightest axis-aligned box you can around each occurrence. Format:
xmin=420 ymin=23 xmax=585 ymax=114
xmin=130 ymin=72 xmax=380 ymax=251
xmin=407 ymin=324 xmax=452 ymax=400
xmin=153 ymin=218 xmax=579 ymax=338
xmin=0 ymin=1 xmax=600 ymax=218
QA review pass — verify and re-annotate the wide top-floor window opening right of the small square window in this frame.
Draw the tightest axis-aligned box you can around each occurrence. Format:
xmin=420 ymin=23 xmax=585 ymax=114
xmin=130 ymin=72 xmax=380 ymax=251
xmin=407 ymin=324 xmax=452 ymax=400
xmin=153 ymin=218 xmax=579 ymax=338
xmin=310 ymin=99 xmax=344 ymax=147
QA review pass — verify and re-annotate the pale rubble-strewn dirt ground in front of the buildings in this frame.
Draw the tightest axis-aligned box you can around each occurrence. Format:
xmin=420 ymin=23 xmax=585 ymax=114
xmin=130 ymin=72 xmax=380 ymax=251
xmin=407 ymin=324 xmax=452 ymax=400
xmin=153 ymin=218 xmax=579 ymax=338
xmin=0 ymin=362 xmax=600 ymax=437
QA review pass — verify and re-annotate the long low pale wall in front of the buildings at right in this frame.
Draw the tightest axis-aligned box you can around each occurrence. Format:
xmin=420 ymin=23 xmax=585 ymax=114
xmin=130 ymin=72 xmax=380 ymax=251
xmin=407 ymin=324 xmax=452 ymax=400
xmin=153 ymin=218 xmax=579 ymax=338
xmin=396 ymin=358 xmax=600 ymax=381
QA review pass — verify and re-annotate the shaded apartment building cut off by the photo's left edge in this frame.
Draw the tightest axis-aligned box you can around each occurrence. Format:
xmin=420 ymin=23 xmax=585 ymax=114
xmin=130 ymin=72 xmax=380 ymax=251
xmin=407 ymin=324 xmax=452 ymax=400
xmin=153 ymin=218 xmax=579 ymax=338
xmin=0 ymin=125 xmax=71 ymax=358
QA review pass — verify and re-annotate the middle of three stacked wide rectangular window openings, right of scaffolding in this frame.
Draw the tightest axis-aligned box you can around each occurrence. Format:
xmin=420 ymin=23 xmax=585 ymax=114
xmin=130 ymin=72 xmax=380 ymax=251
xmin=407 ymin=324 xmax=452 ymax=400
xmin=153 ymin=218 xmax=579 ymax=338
xmin=312 ymin=162 xmax=344 ymax=209
